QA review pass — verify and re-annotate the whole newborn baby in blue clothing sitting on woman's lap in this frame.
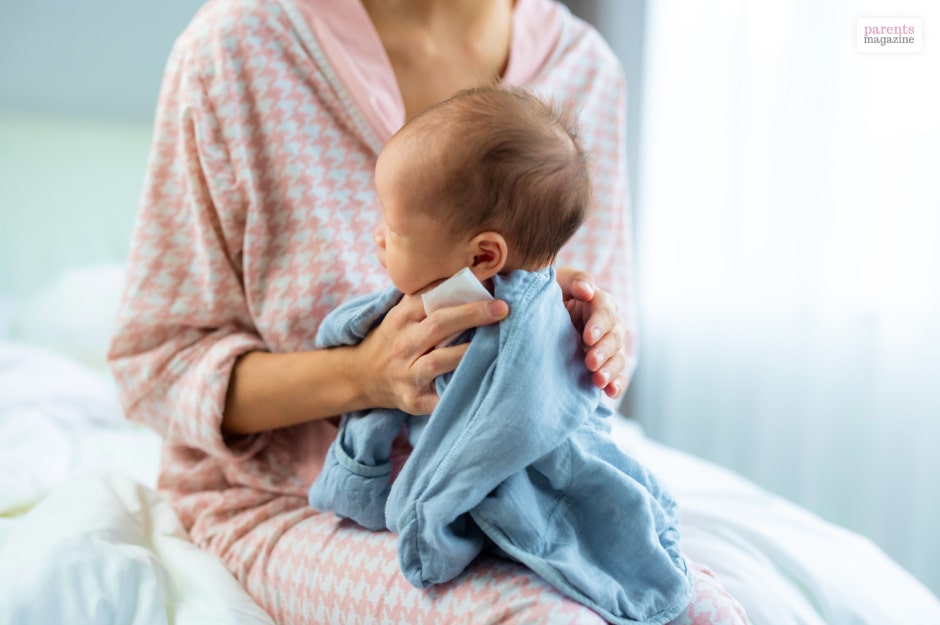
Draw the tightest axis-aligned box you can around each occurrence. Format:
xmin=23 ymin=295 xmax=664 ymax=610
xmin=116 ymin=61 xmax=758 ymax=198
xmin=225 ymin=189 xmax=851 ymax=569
xmin=309 ymin=87 xmax=691 ymax=623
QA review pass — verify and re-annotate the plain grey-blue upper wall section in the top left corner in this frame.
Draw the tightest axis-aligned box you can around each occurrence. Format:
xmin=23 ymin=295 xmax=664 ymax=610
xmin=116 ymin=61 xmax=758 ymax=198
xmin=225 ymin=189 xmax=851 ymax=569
xmin=0 ymin=0 xmax=202 ymax=123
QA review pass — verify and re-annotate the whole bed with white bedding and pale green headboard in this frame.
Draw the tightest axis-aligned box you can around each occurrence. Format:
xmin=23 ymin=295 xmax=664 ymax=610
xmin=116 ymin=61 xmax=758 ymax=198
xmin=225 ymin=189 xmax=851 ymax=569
xmin=0 ymin=117 xmax=940 ymax=625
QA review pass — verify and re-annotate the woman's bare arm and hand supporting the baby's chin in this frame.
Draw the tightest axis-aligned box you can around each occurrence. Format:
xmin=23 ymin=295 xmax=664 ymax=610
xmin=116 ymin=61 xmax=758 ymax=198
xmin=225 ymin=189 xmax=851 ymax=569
xmin=222 ymin=297 xmax=508 ymax=434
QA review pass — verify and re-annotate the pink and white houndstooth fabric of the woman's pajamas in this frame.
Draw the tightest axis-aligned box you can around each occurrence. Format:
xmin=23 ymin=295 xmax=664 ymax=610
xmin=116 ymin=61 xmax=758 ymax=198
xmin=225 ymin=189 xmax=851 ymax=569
xmin=109 ymin=0 xmax=743 ymax=625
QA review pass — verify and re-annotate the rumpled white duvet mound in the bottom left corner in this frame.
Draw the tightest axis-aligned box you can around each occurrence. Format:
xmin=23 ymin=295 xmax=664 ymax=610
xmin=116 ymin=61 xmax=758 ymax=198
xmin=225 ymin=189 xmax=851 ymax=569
xmin=0 ymin=475 xmax=273 ymax=625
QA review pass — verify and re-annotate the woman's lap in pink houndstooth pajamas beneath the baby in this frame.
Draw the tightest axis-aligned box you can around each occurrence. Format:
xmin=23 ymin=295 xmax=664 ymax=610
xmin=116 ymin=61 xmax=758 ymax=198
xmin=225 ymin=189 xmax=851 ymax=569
xmin=224 ymin=510 xmax=747 ymax=625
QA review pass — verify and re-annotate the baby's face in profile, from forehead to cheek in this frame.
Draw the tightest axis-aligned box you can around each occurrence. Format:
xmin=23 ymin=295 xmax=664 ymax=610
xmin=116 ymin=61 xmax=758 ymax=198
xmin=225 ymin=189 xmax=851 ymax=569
xmin=373 ymin=140 xmax=466 ymax=295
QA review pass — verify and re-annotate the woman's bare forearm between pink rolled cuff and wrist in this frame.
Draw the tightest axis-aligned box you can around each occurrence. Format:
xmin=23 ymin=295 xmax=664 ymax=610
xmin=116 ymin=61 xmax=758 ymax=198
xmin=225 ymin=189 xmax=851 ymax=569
xmin=222 ymin=347 xmax=370 ymax=434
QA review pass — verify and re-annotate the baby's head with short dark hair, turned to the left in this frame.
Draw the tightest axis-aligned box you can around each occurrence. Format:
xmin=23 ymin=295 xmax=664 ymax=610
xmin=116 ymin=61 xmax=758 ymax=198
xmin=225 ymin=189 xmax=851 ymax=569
xmin=375 ymin=87 xmax=591 ymax=294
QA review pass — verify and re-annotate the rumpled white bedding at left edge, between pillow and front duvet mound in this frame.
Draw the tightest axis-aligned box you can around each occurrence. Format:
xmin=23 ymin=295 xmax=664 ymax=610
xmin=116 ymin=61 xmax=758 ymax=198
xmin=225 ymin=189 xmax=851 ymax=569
xmin=0 ymin=341 xmax=160 ymax=514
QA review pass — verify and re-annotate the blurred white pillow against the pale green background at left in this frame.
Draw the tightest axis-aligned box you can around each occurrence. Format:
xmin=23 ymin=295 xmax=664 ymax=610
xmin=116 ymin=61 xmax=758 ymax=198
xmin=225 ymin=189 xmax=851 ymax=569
xmin=9 ymin=263 xmax=124 ymax=371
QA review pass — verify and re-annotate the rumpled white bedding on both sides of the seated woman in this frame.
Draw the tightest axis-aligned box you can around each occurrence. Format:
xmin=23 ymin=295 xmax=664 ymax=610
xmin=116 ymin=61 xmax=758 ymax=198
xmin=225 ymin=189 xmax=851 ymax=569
xmin=0 ymin=342 xmax=940 ymax=625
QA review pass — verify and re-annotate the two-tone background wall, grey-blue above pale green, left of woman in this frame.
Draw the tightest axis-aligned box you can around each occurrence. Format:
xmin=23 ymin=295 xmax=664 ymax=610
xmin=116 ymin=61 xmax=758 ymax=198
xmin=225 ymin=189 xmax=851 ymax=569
xmin=0 ymin=0 xmax=201 ymax=296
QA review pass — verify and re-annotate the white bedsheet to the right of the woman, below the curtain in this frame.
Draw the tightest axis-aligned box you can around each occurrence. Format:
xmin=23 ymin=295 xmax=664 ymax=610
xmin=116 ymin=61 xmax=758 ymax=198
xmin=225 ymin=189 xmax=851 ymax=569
xmin=615 ymin=422 xmax=940 ymax=625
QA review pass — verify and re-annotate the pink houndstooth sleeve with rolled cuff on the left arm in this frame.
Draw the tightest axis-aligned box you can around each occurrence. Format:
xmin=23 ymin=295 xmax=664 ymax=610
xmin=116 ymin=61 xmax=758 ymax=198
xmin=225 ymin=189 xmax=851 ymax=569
xmin=108 ymin=40 xmax=266 ymax=456
